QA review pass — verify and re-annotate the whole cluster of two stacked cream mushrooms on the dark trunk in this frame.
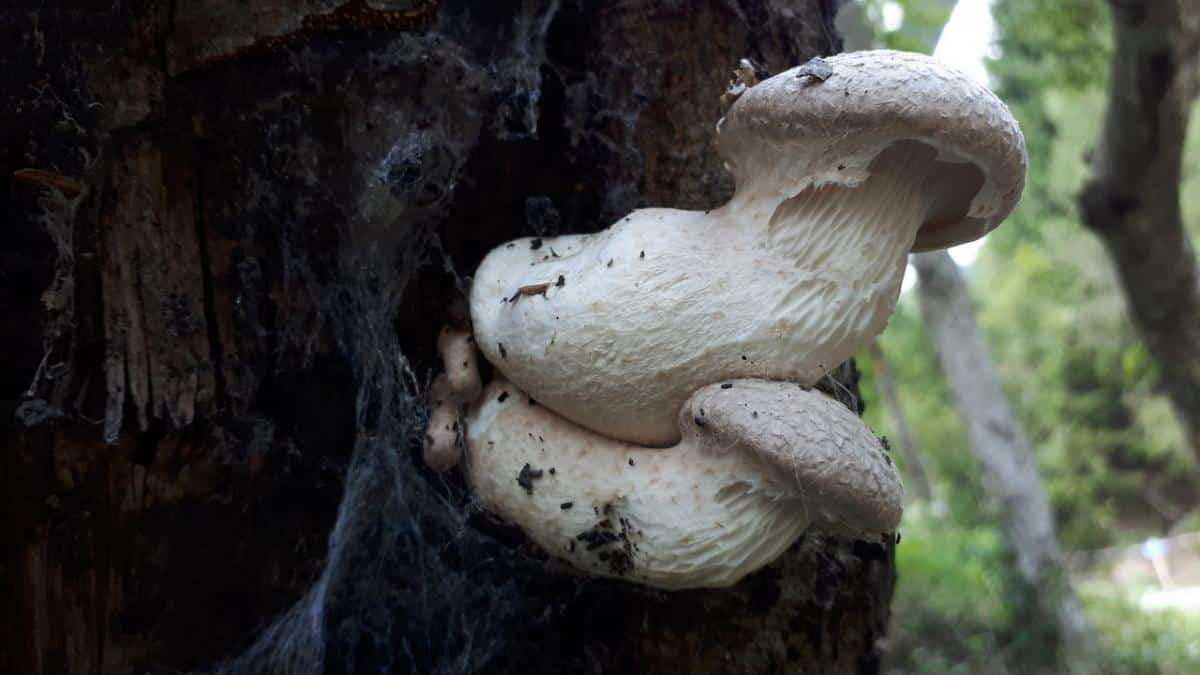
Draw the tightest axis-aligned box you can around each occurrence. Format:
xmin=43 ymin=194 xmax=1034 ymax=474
xmin=434 ymin=50 xmax=1026 ymax=589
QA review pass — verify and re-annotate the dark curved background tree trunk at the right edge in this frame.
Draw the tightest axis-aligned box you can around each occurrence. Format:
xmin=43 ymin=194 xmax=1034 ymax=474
xmin=1079 ymin=0 xmax=1200 ymax=458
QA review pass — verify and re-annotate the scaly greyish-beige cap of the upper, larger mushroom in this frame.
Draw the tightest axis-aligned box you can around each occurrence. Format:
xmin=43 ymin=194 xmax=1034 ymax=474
xmin=716 ymin=49 xmax=1026 ymax=251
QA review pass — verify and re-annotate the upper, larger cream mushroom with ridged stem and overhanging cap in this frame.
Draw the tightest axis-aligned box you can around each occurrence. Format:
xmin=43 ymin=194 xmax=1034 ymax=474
xmin=470 ymin=50 xmax=1025 ymax=447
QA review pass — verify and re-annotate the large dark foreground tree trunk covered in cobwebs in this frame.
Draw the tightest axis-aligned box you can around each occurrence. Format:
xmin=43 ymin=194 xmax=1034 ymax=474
xmin=0 ymin=0 xmax=895 ymax=675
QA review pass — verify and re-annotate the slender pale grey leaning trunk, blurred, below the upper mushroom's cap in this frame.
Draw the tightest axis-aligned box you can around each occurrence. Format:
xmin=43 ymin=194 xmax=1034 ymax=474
xmin=910 ymin=251 xmax=1092 ymax=668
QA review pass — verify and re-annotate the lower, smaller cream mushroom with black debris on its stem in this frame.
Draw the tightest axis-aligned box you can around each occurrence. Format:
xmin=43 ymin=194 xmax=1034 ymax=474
xmin=466 ymin=378 xmax=902 ymax=589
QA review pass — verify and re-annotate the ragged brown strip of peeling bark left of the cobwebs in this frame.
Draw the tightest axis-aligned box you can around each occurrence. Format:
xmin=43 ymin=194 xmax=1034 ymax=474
xmin=101 ymin=136 xmax=214 ymax=443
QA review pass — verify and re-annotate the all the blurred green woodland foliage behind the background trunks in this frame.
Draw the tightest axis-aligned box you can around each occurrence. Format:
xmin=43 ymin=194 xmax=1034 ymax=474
xmin=844 ymin=0 xmax=1200 ymax=674
